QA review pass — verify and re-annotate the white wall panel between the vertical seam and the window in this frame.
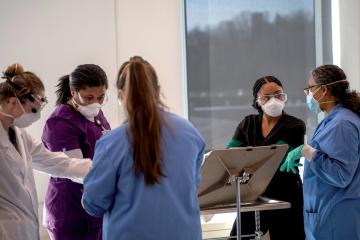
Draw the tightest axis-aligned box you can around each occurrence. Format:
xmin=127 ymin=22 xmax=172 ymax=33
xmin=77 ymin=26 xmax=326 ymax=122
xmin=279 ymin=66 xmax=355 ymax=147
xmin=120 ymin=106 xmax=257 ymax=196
xmin=116 ymin=0 xmax=184 ymax=116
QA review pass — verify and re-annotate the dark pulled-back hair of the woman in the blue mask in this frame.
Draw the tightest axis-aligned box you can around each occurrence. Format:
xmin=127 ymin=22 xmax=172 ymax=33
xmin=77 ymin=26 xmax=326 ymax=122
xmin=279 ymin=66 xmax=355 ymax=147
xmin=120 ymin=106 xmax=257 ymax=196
xmin=311 ymin=65 xmax=360 ymax=116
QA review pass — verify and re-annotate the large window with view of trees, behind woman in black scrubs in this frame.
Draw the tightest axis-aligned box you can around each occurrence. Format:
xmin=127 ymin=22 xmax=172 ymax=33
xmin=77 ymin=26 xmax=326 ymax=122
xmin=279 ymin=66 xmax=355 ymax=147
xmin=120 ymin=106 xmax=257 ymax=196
xmin=185 ymin=0 xmax=330 ymax=149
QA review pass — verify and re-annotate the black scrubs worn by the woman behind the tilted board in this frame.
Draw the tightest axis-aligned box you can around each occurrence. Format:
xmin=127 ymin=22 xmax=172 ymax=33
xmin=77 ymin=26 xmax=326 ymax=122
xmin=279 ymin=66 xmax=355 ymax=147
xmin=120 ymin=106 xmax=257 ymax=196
xmin=227 ymin=113 xmax=305 ymax=240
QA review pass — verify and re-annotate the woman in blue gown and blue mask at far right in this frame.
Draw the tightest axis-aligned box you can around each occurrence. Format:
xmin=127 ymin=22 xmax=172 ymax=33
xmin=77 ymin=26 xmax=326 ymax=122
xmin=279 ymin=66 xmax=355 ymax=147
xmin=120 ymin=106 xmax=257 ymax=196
xmin=285 ymin=65 xmax=360 ymax=240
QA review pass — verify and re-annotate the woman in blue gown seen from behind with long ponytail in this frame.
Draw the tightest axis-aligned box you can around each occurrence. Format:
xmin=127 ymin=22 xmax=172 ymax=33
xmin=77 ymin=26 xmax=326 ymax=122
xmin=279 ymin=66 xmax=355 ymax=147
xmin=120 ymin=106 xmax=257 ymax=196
xmin=83 ymin=57 xmax=205 ymax=240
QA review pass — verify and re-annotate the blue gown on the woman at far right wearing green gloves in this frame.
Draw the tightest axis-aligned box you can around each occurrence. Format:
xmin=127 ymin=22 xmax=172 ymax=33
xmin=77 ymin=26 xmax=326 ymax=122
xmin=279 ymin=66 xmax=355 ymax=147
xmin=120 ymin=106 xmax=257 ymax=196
xmin=303 ymin=105 xmax=360 ymax=240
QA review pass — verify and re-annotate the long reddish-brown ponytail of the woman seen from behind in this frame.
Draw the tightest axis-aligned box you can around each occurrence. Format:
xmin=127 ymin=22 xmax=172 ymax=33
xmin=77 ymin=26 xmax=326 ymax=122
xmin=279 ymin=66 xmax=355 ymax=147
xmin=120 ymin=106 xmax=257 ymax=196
xmin=117 ymin=57 xmax=165 ymax=185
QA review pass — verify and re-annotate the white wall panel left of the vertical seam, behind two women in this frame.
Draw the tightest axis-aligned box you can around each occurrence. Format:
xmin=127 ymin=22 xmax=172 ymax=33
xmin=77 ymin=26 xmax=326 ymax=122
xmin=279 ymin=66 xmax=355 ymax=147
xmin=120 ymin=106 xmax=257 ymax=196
xmin=0 ymin=0 xmax=117 ymax=201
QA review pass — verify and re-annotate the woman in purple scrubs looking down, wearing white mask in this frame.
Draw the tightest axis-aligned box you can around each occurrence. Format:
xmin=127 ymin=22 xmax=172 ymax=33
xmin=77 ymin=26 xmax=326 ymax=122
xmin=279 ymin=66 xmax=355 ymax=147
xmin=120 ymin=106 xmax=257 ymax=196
xmin=42 ymin=64 xmax=110 ymax=240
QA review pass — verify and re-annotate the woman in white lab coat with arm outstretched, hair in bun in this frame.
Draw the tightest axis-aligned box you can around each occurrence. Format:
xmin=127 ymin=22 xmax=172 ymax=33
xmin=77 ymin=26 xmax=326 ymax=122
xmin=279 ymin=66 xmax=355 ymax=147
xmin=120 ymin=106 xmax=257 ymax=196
xmin=0 ymin=64 xmax=91 ymax=240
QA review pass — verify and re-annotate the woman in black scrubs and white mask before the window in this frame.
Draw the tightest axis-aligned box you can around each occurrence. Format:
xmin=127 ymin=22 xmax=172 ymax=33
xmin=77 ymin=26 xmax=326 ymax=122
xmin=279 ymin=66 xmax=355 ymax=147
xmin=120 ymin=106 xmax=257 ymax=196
xmin=227 ymin=76 xmax=305 ymax=240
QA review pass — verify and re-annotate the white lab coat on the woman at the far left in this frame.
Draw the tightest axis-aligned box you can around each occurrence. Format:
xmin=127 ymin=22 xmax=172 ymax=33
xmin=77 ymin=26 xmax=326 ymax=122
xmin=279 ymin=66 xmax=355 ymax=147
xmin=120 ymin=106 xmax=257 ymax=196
xmin=0 ymin=123 xmax=92 ymax=240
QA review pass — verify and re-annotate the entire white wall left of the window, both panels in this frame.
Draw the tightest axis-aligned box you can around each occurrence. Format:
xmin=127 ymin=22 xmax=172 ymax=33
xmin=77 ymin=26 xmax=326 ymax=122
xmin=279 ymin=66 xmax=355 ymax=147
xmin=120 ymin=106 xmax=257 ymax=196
xmin=0 ymin=0 xmax=184 ymax=200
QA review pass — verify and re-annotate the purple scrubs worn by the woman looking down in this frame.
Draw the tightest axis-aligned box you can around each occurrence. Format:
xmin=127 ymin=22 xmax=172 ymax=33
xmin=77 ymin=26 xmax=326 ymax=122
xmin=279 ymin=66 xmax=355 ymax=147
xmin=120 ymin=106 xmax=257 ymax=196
xmin=42 ymin=104 xmax=110 ymax=233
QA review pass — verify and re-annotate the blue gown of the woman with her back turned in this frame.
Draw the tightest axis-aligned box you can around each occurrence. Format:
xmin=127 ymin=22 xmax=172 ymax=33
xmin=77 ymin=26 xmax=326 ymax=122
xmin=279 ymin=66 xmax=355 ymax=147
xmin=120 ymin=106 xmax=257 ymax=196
xmin=83 ymin=112 xmax=205 ymax=240
